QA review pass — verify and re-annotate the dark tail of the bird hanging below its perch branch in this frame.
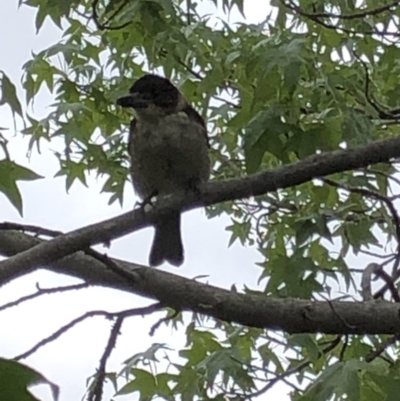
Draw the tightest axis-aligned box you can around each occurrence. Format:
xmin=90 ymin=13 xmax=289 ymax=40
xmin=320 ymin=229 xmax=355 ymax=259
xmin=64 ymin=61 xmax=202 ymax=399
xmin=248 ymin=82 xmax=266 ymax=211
xmin=150 ymin=213 xmax=183 ymax=266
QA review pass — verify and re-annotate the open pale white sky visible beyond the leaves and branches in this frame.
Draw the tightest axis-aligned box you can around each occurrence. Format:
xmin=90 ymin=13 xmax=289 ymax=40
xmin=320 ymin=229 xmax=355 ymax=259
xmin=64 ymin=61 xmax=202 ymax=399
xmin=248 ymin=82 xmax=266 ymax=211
xmin=0 ymin=0 xmax=288 ymax=401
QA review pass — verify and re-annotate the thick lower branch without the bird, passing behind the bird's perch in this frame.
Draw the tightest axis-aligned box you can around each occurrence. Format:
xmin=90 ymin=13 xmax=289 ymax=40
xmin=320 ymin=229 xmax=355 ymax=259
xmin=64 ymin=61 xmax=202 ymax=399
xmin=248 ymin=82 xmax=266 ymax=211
xmin=0 ymin=231 xmax=400 ymax=334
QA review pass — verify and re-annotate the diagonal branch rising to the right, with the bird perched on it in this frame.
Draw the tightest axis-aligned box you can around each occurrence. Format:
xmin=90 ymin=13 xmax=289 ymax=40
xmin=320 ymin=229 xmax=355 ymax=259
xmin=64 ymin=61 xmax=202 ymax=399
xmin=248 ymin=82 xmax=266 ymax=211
xmin=0 ymin=136 xmax=400 ymax=285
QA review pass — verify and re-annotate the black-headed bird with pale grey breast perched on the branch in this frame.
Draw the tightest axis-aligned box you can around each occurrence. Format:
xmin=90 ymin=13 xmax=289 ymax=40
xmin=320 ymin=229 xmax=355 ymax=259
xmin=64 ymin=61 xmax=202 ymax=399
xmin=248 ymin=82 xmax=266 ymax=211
xmin=117 ymin=74 xmax=210 ymax=266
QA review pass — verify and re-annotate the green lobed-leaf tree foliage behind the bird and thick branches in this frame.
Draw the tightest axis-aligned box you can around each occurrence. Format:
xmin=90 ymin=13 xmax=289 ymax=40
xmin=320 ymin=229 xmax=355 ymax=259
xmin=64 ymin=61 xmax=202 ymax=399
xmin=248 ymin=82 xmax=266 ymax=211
xmin=0 ymin=0 xmax=400 ymax=401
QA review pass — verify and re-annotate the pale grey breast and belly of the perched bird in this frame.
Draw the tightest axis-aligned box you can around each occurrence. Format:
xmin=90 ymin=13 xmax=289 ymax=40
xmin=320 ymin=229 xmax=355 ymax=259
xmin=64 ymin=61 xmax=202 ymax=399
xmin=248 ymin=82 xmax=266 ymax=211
xmin=130 ymin=115 xmax=210 ymax=196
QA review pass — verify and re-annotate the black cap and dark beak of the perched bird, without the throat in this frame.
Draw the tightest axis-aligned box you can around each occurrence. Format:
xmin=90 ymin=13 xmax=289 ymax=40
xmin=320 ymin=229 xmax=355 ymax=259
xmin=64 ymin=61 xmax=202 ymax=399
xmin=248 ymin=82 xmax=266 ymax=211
xmin=117 ymin=74 xmax=181 ymax=110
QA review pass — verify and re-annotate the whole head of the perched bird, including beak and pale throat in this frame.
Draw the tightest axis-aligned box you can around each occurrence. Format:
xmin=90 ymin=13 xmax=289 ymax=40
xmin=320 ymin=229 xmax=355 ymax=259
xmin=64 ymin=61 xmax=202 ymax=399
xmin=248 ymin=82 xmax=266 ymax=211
xmin=117 ymin=74 xmax=187 ymax=119
